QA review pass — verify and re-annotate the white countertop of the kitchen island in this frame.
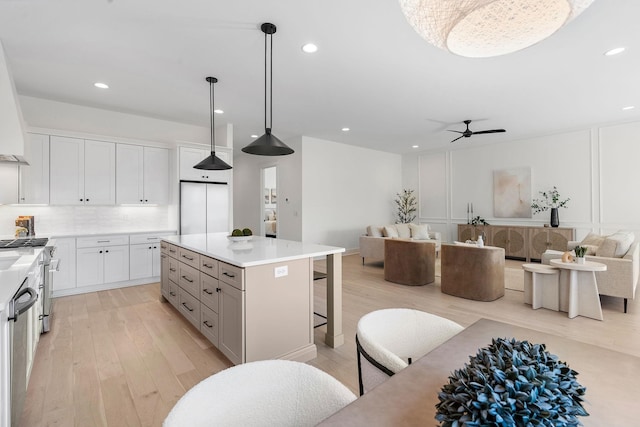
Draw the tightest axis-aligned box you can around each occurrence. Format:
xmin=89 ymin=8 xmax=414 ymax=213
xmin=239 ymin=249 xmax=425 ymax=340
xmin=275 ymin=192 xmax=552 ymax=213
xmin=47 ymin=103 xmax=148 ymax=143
xmin=162 ymin=233 xmax=345 ymax=267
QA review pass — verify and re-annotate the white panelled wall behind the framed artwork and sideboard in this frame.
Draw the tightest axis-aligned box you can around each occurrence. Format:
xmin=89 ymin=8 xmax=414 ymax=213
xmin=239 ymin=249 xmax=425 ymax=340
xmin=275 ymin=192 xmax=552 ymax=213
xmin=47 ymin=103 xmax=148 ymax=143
xmin=403 ymin=122 xmax=640 ymax=241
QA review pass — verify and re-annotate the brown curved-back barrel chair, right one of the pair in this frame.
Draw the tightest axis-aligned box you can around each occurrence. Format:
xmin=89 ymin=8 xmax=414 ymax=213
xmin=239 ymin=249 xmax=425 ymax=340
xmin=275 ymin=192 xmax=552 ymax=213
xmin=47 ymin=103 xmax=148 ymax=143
xmin=440 ymin=244 xmax=504 ymax=301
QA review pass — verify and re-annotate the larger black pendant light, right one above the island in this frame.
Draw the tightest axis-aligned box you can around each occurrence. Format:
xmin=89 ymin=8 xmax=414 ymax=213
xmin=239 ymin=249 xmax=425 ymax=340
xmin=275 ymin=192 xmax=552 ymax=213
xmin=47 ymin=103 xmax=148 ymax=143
xmin=242 ymin=22 xmax=293 ymax=156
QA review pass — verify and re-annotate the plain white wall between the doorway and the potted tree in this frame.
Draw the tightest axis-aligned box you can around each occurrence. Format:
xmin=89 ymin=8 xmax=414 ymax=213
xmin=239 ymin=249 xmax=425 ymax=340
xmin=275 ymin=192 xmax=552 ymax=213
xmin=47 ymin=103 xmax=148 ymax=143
xmin=302 ymin=137 xmax=402 ymax=251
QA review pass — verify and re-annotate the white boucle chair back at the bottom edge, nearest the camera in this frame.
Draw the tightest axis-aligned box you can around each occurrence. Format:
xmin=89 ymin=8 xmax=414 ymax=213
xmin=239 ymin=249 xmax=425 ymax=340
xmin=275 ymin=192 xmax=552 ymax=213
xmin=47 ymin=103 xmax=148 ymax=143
xmin=163 ymin=360 xmax=356 ymax=427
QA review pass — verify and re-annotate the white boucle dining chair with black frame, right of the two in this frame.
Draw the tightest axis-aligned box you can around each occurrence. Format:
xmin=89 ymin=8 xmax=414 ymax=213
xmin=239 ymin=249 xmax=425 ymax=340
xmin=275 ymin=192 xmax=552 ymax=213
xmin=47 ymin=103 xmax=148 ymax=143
xmin=356 ymin=308 xmax=464 ymax=395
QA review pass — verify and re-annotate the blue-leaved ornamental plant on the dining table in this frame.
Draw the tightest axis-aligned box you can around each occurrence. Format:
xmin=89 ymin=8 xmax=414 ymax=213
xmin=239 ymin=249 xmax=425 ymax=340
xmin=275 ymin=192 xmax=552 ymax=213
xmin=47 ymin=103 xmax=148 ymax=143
xmin=435 ymin=338 xmax=589 ymax=427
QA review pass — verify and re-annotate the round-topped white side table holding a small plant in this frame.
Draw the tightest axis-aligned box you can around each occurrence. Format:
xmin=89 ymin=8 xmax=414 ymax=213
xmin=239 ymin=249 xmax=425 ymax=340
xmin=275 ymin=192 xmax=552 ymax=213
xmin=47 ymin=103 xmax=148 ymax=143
xmin=549 ymin=259 xmax=607 ymax=320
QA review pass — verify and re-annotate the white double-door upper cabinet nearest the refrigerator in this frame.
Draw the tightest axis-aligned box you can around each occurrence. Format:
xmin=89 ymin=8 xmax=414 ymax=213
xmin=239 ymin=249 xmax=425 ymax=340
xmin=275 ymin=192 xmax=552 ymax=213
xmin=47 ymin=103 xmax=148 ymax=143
xmin=116 ymin=144 xmax=169 ymax=205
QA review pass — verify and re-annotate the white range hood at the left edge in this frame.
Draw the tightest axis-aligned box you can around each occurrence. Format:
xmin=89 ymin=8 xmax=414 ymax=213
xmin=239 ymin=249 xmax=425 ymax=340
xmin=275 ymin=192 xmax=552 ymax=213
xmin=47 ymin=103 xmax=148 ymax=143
xmin=0 ymin=41 xmax=28 ymax=164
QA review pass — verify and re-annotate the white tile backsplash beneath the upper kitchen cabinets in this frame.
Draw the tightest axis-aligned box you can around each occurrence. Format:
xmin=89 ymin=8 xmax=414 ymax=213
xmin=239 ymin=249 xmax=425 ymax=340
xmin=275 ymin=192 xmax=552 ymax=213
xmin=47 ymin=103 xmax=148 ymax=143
xmin=0 ymin=205 xmax=177 ymax=238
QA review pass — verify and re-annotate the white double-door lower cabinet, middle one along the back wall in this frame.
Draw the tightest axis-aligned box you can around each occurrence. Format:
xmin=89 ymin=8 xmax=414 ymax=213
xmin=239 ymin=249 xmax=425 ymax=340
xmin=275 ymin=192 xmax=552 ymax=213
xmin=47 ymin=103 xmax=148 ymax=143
xmin=76 ymin=245 xmax=129 ymax=286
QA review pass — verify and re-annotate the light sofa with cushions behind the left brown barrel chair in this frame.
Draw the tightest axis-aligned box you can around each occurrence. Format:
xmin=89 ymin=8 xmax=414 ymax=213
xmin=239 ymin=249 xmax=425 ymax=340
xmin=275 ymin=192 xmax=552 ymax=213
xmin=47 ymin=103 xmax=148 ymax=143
xmin=360 ymin=224 xmax=442 ymax=264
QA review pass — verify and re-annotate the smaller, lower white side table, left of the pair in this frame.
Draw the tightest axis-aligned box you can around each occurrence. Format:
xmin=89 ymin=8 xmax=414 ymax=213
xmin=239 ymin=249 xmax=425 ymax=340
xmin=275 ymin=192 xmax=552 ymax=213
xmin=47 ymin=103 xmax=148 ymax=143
xmin=522 ymin=264 xmax=560 ymax=311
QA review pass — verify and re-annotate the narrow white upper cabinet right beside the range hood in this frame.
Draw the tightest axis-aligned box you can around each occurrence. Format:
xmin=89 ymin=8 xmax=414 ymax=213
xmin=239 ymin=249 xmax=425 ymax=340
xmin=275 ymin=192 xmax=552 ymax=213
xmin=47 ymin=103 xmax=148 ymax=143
xmin=18 ymin=133 xmax=49 ymax=204
